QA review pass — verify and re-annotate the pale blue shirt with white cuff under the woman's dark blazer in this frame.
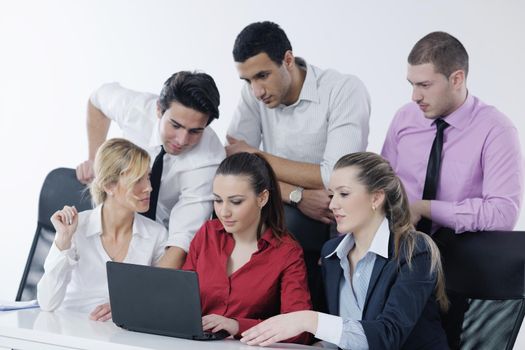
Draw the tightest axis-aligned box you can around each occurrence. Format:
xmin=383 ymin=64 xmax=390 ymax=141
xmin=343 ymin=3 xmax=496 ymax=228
xmin=315 ymin=218 xmax=390 ymax=350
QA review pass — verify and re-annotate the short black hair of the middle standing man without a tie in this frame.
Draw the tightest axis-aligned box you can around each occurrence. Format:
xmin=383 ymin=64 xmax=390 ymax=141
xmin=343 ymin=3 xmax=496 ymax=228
xmin=233 ymin=21 xmax=292 ymax=66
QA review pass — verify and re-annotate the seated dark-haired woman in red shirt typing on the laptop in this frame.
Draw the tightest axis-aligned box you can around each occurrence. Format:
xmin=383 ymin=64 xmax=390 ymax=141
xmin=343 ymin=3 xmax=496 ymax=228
xmin=183 ymin=153 xmax=311 ymax=343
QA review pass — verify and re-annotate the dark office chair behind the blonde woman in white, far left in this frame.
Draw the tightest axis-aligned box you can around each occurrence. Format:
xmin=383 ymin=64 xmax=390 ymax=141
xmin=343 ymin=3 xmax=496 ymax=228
xmin=16 ymin=168 xmax=92 ymax=301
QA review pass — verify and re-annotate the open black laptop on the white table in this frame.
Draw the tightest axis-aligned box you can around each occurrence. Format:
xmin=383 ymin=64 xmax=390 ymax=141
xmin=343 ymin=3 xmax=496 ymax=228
xmin=106 ymin=261 xmax=230 ymax=340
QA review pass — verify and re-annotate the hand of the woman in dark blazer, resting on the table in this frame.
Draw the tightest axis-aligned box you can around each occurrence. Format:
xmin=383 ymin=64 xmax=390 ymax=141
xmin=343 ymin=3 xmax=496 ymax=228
xmin=241 ymin=310 xmax=317 ymax=346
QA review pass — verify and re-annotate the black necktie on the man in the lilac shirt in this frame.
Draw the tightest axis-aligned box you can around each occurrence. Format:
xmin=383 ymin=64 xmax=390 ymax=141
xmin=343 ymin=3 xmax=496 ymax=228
xmin=416 ymin=118 xmax=449 ymax=234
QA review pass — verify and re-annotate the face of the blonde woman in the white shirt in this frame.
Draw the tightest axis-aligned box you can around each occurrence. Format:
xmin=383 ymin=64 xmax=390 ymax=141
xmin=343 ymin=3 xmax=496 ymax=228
xmin=110 ymin=169 xmax=151 ymax=213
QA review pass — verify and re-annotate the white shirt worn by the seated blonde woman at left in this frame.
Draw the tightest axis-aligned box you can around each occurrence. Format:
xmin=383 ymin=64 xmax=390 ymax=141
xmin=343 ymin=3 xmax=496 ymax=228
xmin=37 ymin=205 xmax=168 ymax=313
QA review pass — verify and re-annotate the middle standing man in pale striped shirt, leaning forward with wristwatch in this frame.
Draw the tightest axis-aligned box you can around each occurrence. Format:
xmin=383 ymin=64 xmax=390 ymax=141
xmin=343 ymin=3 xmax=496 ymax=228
xmin=226 ymin=22 xmax=370 ymax=310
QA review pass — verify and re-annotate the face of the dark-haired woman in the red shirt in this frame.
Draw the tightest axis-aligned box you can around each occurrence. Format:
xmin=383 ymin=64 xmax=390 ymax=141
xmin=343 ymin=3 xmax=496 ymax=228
xmin=213 ymin=175 xmax=268 ymax=235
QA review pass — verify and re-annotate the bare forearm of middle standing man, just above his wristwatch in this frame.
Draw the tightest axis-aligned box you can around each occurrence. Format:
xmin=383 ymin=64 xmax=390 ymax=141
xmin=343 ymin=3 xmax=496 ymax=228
xmin=260 ymin=152 xmax=324 ymax=189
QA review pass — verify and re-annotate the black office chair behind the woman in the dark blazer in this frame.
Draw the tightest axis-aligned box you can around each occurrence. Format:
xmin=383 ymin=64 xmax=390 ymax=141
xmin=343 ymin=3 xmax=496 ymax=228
xmin=433 ymin=230 xmax=525 ymax=350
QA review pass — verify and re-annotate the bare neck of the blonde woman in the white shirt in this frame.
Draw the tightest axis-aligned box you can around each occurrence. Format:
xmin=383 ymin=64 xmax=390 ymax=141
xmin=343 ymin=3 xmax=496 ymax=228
xmin=102 ymin=199 xmax=135 ymax=238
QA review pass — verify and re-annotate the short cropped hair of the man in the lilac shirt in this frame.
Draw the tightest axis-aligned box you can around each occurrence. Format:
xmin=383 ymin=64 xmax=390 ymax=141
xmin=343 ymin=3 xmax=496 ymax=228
xmin=408 ymin=32 xmax=468 ymax=77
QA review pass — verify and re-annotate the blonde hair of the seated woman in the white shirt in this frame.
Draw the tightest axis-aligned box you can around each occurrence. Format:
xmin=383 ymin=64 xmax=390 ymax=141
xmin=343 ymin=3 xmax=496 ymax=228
xmin=89 ymin=138 xmax=150 ymax=205
